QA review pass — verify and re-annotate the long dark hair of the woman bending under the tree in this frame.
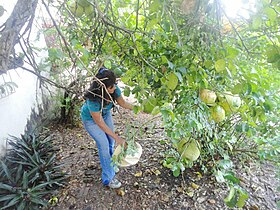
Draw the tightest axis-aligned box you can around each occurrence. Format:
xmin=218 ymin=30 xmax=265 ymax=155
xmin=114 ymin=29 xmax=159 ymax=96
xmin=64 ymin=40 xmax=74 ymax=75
xmin=84 ymin=67 xmax=116 ymax=104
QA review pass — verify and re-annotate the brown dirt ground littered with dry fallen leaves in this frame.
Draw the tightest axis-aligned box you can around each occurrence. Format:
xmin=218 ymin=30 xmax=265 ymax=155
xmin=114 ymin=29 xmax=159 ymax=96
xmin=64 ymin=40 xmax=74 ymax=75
xmin=50 ymin=110 xmax=280 ymax=210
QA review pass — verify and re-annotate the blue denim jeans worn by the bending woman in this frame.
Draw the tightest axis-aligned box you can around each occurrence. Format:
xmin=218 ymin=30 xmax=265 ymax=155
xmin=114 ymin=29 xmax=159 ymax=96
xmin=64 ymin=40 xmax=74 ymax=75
xmin=83 ymin=113 xmax=115 ymax=185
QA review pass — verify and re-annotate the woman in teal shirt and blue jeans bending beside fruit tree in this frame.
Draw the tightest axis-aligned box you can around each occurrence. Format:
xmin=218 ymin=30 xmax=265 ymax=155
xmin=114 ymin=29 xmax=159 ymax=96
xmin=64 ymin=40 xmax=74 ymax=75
xmin=81 ymin=67 xmax=133 ymax=188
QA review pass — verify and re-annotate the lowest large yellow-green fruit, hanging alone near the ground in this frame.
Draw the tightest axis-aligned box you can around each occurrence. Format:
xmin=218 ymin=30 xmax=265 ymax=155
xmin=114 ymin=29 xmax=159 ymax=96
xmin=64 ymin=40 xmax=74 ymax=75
xmin=178 ymin=139 xmax=200 ymax=161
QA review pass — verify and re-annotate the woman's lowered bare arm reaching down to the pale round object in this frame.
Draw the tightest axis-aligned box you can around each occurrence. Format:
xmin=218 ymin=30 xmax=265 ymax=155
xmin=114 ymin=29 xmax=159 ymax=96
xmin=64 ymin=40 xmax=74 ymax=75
xmin=90 ymin=112 xmax=125 ymax=145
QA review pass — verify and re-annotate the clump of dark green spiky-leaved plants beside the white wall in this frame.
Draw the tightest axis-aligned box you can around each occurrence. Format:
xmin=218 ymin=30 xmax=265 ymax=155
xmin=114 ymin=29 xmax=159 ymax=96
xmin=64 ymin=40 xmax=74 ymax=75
xmin=0 ymin=128 xmax=68 ymax=210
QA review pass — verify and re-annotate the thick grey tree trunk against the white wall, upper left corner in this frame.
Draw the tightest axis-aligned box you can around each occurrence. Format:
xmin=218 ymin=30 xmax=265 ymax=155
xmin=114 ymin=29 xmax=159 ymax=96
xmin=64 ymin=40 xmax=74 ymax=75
xmin=0 ymin=0 xmax=38 ymax=74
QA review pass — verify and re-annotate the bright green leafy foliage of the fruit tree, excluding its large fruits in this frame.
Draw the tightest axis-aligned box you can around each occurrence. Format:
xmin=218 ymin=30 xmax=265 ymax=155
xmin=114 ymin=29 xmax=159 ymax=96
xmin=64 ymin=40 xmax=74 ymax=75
xmin=31 ymin=0 xmax=280 ymax=206
